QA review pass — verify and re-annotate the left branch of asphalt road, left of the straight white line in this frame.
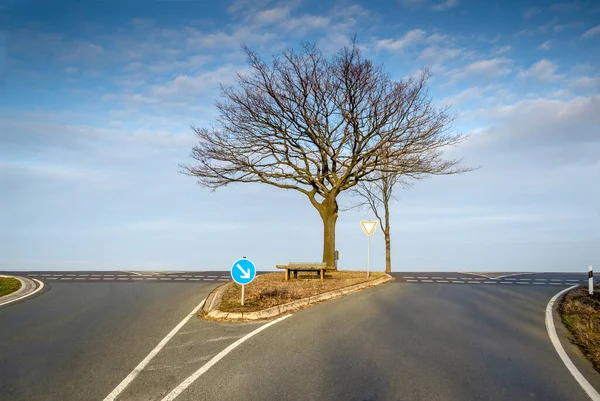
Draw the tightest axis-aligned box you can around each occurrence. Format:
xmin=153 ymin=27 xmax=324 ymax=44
xmin=0 ymin=283 xmax=223 ymax=401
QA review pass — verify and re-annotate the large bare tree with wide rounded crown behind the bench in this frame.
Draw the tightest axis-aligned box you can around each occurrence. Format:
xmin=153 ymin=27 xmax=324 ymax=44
xmin=181 ymin=40 xmax=462 ymax=266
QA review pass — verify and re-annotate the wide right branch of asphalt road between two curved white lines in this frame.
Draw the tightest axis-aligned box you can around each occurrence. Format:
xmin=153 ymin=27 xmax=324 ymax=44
xmin=178 ymin=283 xmax=597 ymax=401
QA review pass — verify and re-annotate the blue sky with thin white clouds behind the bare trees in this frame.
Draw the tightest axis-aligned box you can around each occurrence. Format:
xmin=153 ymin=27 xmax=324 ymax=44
xmin=0 ymin=0 xmax=600 ymax=271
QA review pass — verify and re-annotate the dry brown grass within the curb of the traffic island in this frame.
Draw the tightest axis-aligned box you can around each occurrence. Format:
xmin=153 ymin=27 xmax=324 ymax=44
xmin=219 ymin=271 xmax=385 ymax=312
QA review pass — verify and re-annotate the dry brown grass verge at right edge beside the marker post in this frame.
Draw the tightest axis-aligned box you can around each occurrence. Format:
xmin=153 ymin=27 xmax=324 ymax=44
xmin=558 ymin=287 xmax=600 ymax=372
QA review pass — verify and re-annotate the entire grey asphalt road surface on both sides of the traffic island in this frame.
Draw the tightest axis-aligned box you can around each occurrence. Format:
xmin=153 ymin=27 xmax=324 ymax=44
xmin=0 ymin=272 xmax=600 ymax=401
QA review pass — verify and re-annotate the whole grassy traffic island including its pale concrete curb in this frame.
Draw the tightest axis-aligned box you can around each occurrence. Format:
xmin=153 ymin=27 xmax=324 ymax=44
xmin=200 ymin=271 xmax=392 ymax=320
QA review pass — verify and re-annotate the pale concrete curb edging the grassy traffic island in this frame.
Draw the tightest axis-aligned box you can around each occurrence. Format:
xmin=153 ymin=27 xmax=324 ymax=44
xmin=203 ymin=274 xmax=394 ymax=321
